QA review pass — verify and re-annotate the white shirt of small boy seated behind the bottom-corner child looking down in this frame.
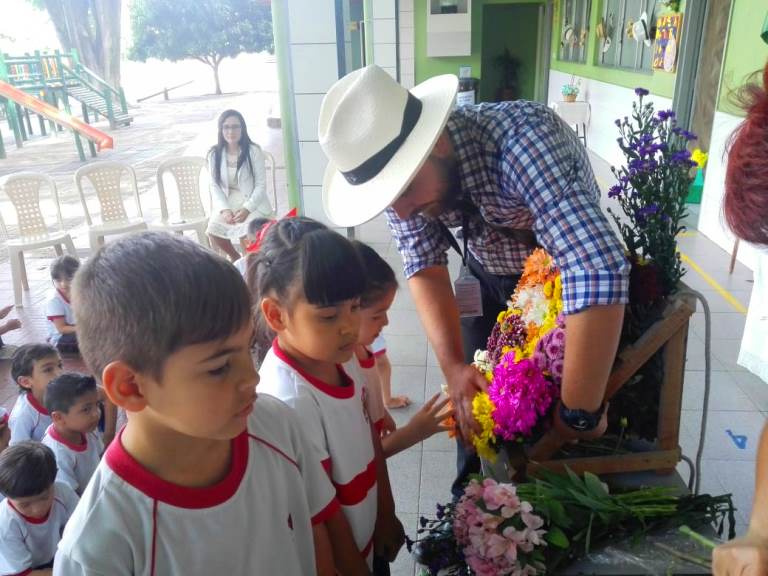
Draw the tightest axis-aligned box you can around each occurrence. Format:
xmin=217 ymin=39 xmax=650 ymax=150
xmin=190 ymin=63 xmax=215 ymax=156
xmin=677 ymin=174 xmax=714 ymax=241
xmin=43 ymin=424 xmax=104 ymax=494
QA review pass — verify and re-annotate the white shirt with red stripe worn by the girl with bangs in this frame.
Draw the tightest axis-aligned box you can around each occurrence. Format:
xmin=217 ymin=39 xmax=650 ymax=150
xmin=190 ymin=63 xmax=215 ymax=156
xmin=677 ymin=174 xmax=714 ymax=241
xmin=259 ymin=340 xmax=377 ymax=565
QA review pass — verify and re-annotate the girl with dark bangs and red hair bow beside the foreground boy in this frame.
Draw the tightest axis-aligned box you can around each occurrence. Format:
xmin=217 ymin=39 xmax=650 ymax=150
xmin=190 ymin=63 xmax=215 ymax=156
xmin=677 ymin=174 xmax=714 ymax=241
xmin=255 ymin=218 xmax=404 ymax=574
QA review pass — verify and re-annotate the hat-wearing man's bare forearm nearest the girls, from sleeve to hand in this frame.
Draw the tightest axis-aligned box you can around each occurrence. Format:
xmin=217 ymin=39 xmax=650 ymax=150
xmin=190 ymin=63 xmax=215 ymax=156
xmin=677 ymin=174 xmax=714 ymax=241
xmin=408 ymin=266 xmax=464 ymax=373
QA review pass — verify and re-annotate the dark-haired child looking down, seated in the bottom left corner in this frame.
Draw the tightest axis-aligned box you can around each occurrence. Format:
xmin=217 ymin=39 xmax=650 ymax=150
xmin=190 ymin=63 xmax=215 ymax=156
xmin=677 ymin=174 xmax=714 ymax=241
xmin=0 ymin=441 xmax=77 ymax=576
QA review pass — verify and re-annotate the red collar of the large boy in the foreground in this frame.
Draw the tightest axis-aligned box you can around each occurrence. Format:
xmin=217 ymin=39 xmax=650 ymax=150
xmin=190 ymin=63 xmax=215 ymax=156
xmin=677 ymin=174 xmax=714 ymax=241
xmin=104 ymin=429 xmax=248 ymax=510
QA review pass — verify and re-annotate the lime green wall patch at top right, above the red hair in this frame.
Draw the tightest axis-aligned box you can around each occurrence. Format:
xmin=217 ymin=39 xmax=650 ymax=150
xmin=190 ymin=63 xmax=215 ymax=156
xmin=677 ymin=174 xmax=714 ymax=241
xmin=717 ymin=0 xmax=768 ymax=116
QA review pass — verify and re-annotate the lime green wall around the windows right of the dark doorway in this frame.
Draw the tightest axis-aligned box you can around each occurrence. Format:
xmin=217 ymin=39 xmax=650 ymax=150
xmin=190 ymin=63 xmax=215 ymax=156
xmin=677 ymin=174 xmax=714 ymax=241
xmin=550 ymin=0 xmax=688 ymax=98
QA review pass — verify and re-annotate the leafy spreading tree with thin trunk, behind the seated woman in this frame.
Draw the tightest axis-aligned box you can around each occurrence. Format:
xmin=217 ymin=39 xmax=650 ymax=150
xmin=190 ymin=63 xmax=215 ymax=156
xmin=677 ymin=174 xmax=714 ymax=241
xmin=128 ymin=0 xmax=274 ymax=94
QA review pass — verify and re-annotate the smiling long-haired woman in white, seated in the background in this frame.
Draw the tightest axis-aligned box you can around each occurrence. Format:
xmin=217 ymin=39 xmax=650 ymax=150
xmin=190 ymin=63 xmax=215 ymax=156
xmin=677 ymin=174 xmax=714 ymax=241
xmin=208 ymin=110 xmax=274 ymax=262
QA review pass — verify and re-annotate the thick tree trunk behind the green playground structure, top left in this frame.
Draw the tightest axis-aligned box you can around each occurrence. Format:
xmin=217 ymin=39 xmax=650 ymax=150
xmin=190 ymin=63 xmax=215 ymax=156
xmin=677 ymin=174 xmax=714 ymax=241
xmin=30 ymin=0 xmax=122 ymax=86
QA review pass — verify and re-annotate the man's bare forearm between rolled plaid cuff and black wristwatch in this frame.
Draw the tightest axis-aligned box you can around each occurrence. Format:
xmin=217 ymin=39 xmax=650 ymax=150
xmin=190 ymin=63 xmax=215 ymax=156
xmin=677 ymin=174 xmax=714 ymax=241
xmin=561 ymin=304 xmax=624 ymax=412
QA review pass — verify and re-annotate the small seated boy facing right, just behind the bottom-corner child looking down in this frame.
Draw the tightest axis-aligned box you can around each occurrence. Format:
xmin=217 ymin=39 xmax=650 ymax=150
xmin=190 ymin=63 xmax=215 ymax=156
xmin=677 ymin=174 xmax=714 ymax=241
xmin=43 ymin=373 xmax=104 ymax=494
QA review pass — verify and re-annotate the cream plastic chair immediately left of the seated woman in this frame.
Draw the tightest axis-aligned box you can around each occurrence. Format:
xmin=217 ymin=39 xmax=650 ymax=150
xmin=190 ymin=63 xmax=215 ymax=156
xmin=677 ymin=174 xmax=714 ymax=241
xmin=151 ymin=156 xmax=210 ymax=246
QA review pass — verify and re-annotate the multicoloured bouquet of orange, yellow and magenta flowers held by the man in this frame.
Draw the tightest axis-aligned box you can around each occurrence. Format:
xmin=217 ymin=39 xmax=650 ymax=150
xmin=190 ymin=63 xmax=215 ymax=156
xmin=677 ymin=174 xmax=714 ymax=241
xmin=472 ymin=248 xmax=565 ymax=462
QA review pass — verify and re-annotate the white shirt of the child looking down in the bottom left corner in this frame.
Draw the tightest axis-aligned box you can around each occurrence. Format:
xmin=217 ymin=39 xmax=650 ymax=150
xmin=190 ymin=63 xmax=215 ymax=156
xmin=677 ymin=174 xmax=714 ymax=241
xmin=0 ymin=483 xmax=77 ymax=575
